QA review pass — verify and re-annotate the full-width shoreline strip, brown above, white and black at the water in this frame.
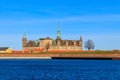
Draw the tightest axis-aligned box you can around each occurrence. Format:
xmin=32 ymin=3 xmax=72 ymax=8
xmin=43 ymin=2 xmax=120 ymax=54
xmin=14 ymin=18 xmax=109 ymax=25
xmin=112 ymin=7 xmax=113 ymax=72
xmin=0 ymin=53 xmax=120 ymax=60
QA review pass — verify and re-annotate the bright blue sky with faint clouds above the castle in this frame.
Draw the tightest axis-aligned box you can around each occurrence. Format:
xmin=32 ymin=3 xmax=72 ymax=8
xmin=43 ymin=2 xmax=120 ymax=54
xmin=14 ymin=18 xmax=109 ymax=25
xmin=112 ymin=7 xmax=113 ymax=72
xmin=0 ymin=0 xmax=120 ymax=50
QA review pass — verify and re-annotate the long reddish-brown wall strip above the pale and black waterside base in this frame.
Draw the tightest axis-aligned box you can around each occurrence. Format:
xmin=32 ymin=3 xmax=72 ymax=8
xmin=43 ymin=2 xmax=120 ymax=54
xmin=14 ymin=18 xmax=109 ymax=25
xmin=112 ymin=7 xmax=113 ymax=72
xmin=0 ymin=53 xmax=120 ymax=58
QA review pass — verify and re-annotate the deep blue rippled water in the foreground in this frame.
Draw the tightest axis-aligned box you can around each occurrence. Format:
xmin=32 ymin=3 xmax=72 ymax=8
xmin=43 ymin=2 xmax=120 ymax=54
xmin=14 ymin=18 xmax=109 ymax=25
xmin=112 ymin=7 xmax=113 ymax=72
xmin=0 ymin=60 xmax=120 ymax=80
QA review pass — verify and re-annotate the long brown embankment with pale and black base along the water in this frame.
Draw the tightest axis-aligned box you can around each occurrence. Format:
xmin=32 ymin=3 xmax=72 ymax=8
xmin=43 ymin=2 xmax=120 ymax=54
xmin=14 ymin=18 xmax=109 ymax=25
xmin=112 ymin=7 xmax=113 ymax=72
xmin=0 ymin=53 xmax=120 ymax=59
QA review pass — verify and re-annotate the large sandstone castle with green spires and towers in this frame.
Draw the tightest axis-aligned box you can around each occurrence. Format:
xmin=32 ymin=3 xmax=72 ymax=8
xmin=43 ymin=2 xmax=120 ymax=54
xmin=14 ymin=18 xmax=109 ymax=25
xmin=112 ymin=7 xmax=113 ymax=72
xmin=22 ymin=27 xmax=83 ymax=52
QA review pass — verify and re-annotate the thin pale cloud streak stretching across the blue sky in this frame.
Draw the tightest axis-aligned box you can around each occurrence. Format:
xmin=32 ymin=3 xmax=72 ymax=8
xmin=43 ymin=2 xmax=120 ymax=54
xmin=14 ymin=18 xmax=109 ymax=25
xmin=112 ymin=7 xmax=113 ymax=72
xmin=0 ymin=14 xmax=120 ymax=26
